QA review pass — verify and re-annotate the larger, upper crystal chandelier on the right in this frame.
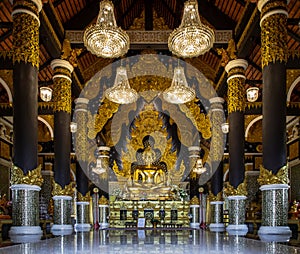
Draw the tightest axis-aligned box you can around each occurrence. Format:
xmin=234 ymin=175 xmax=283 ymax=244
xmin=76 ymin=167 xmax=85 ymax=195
xmin=168 ymin=0 xmax=215 ymax=57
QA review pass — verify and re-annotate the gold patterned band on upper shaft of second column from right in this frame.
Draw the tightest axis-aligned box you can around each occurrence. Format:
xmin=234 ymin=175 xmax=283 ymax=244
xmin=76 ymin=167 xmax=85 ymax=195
xmin=227 ymin=75 xmax=245 ymax=114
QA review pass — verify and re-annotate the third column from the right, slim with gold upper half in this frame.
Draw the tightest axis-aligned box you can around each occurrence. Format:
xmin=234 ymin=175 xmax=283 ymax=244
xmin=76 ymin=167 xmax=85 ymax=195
xmin=208 ymin=97 xmax=226 ymax=231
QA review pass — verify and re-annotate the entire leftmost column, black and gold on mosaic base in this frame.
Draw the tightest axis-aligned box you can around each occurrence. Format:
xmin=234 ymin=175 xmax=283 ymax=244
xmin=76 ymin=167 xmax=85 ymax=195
xmin=9 ymin=0 xmax=42 ymax=242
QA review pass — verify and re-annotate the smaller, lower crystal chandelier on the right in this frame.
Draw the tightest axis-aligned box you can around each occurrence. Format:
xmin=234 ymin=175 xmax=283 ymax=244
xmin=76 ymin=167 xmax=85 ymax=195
xmin=163 ymin=66 xmax=196 ymax=104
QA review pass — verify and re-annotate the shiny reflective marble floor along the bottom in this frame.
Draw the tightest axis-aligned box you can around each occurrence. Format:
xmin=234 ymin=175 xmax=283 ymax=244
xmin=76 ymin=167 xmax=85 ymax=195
xmin=0 ymin=230 xmax=300 ymax=254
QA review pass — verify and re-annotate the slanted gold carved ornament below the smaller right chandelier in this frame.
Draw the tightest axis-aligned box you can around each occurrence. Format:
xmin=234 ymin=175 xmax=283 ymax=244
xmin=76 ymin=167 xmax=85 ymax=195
xmin=179 ymin=99 xmax=211 ymax=139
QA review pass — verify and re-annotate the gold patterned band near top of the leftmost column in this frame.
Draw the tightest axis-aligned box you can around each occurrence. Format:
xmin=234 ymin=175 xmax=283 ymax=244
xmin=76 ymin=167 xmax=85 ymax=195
xmin=12 ymin=13 xmax=39 ymax=68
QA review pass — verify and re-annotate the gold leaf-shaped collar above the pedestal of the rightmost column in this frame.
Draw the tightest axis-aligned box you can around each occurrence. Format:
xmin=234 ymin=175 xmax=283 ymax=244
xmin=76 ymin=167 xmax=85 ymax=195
xmin=257 ymin=165 xmax=290 ymax=185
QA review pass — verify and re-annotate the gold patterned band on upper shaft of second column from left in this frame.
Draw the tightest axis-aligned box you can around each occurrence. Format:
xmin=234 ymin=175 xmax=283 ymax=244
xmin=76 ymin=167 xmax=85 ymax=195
xmin=53 ymin=77 xmax=72 ymax=114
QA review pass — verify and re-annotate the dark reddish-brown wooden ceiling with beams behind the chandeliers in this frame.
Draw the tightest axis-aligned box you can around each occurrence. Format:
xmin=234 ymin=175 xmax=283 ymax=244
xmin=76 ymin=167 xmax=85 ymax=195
xmin=0 ymin=0 xmax=300 ymax=108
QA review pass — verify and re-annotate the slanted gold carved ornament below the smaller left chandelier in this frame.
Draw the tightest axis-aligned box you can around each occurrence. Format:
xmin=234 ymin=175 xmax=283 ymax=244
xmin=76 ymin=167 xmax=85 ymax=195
xmin=87 ymin=99 xmax=119 ymax=139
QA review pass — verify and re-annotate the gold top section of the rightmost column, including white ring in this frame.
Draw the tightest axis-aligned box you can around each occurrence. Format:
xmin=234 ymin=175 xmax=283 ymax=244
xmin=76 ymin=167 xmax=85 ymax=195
xmin=258 ymin=0 xmax=288 ymax=68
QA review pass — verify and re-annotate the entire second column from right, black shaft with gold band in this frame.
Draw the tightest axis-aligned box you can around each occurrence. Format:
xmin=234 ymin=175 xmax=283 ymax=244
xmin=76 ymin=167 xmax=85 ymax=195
xmin=225 ymin=59 xmax=248 ymax=235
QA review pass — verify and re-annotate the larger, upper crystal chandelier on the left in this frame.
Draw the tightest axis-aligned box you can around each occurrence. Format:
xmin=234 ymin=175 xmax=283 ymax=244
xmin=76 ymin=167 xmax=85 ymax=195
xmin=83 ymin=0 xmax=129 ymax=58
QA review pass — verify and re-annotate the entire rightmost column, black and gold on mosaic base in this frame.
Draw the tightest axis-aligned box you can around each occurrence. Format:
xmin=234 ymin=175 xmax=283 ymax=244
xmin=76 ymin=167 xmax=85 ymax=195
xmin=258 ymin=0 xmax=291 ymax=239
